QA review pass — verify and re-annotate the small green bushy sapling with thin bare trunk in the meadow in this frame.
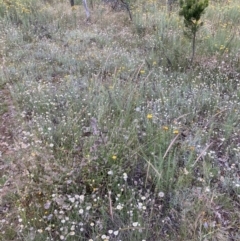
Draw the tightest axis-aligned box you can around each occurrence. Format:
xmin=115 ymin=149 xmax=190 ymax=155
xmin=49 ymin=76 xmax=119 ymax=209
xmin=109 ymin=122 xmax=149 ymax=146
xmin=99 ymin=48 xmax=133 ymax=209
xmin=179 ymin=0 xmax=208 ymax=65
